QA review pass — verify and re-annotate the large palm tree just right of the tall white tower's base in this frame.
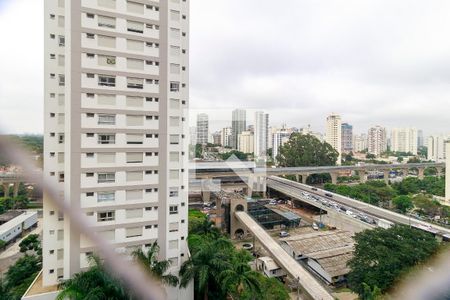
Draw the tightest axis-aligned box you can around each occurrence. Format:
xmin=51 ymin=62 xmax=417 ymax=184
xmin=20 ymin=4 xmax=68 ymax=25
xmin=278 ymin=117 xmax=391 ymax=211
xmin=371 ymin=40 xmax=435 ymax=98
xmin=180 ymin=235 xmax=233 ymax=300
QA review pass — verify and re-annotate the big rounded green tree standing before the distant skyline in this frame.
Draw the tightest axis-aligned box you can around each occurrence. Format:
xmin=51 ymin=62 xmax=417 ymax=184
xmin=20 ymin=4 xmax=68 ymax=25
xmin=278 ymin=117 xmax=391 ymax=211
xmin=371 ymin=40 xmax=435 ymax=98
xmin=276 ymin=133 xmax=339 ymax=167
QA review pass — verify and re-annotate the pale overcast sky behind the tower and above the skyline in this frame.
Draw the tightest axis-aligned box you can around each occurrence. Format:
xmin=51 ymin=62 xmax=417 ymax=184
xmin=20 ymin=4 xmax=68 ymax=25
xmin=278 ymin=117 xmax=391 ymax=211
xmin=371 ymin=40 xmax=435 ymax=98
xmin=0 ymin=0 xmax=450 ymax=134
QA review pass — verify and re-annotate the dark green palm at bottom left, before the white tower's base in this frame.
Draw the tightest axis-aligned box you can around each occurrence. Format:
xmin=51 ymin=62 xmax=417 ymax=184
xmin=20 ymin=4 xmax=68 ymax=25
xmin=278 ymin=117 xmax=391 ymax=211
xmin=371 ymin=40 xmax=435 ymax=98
xmin=56 ymin=256 xmax=133 ymax=300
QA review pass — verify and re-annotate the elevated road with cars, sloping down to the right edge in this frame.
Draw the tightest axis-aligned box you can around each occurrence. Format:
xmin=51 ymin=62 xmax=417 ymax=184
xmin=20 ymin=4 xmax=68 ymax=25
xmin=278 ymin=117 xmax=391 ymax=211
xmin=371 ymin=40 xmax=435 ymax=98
xmin=267 ymin=176 xmax=450 ymax=235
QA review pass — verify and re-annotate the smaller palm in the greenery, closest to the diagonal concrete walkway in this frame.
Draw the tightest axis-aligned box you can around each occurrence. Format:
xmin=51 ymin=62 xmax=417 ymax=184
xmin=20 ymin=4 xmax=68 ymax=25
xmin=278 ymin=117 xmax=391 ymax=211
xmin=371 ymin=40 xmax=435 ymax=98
xmin=219 ymin=250 xmax=261 ymax=299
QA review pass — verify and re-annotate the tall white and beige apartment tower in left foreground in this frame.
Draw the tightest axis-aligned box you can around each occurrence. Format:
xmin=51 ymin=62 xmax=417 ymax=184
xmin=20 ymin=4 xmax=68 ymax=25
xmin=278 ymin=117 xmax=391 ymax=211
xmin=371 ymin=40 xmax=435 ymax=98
xmin=42 ymin=0 xmax=192 ymax=299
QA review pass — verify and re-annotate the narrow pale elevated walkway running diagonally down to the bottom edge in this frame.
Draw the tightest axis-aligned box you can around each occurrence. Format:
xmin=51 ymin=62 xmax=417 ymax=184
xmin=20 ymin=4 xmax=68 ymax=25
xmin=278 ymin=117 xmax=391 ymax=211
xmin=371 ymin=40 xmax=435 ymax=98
xmin=235 ymin=211 xmax=334 ymax=300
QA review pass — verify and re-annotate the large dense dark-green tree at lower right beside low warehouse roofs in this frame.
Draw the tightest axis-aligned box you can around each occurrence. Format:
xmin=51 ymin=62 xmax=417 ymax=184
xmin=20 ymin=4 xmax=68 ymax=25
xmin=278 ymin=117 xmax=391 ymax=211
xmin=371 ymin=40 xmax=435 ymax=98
xmin=348 ymin=225 xmax=438 ymax=299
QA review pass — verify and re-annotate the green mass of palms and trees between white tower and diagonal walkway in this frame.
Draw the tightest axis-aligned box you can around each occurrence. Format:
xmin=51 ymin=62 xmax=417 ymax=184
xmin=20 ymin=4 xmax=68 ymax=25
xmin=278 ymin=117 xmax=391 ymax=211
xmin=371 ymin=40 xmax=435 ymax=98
xmin=180 ymin=211 xmax=289 ymax=300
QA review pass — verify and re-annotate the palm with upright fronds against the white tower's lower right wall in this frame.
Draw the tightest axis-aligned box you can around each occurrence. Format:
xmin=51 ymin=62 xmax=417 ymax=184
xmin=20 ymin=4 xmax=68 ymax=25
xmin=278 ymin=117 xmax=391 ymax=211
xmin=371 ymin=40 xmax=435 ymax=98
xmin=133 ymin=242 xmax=178 ymax=287
